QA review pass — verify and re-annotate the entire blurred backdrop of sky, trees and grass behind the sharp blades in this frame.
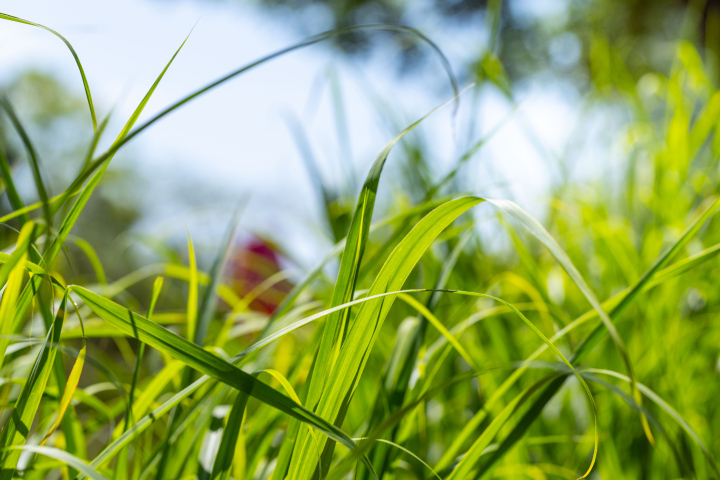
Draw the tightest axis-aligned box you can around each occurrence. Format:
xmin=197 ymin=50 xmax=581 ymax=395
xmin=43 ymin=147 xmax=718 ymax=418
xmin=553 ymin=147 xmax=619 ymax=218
xmin=0 ymin=0 xmax=720 ymax=479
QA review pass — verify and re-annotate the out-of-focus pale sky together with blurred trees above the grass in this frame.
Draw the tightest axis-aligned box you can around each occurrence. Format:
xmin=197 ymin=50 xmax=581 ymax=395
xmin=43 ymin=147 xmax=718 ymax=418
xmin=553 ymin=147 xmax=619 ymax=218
xmin=0 ymin=0 xmax=708 ymax=280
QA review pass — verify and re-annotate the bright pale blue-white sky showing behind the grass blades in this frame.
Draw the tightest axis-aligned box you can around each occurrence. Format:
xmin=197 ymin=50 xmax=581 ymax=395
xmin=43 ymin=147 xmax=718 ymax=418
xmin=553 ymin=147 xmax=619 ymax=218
xmin=0 ymin=0 xmax=578 ymax=266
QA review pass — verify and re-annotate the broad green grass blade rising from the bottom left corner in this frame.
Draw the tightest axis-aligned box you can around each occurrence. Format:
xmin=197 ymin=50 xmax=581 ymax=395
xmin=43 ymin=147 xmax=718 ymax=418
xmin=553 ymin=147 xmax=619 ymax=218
xmin=0 ymin=293 xmax=67 ymax=480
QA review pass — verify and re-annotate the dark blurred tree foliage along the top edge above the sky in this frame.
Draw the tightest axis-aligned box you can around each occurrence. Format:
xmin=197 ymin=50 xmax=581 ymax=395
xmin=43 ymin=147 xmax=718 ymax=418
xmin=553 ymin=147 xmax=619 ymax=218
xmin=156 ymin=0 xmax=720 ymax=85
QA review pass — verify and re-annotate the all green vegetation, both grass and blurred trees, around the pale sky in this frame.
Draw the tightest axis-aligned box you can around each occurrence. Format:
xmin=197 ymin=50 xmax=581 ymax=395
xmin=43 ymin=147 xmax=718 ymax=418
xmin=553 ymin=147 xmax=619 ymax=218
xmin=0 ymin=0 xmax=720 ymax=480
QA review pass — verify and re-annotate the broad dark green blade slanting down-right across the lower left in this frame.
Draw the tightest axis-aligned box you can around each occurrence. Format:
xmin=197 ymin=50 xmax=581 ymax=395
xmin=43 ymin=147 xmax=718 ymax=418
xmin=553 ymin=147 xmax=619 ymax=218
xmin=68 ymin=285 xmax=377 ymax=478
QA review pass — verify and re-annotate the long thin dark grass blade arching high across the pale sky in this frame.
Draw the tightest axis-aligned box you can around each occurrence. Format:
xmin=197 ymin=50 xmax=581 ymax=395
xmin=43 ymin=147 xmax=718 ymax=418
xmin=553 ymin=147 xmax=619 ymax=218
xmin=60 ymin=24 xmax=458 ymax=209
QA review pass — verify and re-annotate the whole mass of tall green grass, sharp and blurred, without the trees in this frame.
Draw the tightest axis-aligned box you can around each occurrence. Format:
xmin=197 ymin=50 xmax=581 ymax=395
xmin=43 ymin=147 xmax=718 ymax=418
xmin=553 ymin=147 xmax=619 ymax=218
xmin=0 ymin=8 xmax=720 ymax=480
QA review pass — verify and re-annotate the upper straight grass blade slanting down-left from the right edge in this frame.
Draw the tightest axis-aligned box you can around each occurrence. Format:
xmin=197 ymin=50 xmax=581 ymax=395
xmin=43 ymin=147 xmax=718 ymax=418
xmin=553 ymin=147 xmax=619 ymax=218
xmin=472 ymin=194 xmax=720 ymax=472
